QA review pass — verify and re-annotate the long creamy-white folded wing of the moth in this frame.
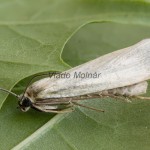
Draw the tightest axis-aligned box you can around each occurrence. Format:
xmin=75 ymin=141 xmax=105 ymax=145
xmin=27 ymin=39 xmax=150 ymax=99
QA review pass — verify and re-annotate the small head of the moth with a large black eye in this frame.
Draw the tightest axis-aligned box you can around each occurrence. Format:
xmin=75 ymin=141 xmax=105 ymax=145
xmin=18 ymin=96 xmax=32 ymax=112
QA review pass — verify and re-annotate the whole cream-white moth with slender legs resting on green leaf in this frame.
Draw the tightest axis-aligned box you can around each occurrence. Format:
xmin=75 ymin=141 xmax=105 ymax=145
xmin=0 ymin=39 xmax=150 ymax=113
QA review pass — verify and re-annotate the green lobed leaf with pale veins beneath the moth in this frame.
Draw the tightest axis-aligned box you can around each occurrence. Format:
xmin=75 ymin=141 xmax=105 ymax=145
xmin=0 ymin=0 xmax=150 ymax=150
